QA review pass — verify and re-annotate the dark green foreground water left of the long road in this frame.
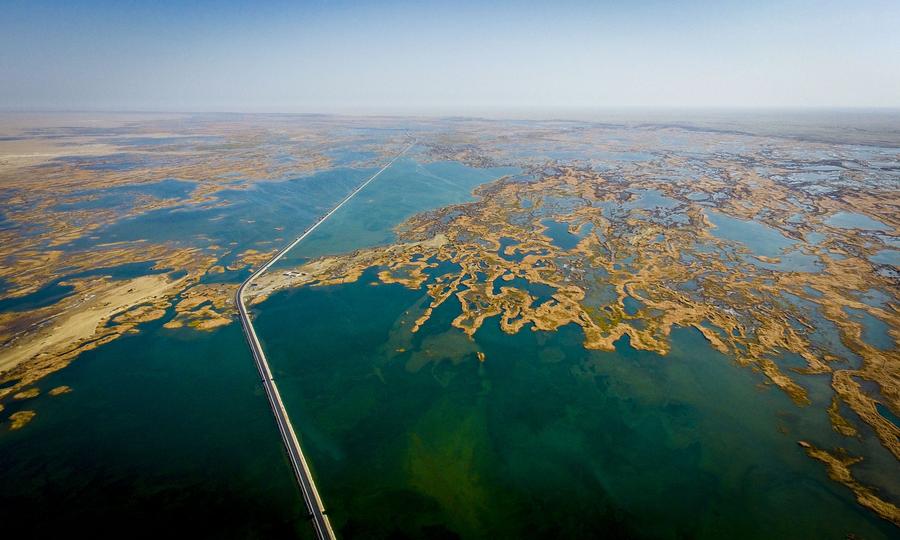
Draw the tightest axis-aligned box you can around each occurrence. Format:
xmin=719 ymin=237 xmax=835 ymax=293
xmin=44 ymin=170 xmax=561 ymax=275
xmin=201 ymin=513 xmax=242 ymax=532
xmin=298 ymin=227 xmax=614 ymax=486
xmin=0 ymin=314 xmax=313 ymax=538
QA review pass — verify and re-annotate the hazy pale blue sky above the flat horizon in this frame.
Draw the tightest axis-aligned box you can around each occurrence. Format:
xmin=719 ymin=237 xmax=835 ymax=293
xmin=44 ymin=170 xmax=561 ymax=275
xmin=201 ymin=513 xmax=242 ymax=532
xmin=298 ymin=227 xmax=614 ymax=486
xmin=0 ymin=0 xmax=900 ymax=113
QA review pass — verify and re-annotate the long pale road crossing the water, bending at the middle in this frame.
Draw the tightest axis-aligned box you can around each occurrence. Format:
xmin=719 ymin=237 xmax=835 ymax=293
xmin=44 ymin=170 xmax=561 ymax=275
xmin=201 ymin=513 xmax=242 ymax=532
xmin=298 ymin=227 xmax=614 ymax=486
xmin=234 ymin=139 xmax=416 ymax=540
